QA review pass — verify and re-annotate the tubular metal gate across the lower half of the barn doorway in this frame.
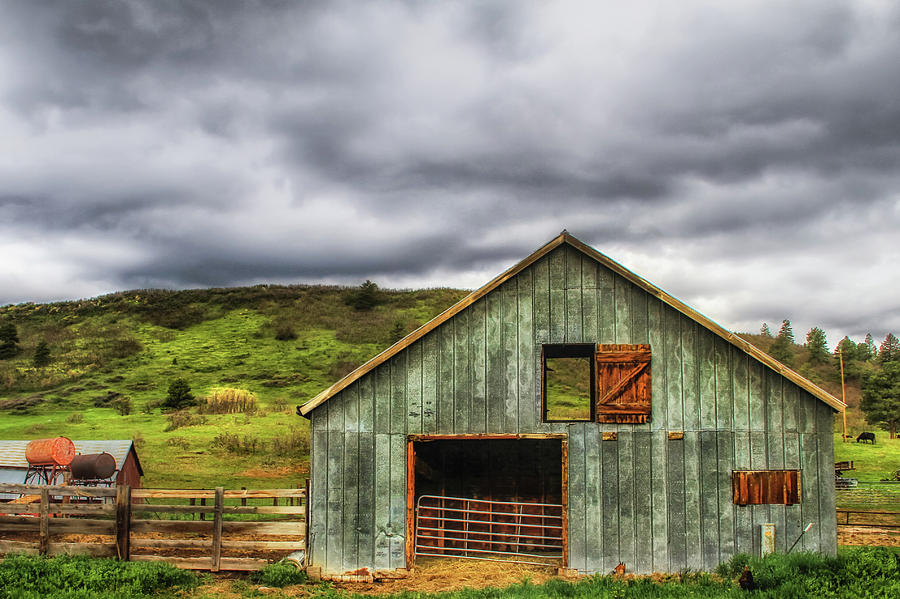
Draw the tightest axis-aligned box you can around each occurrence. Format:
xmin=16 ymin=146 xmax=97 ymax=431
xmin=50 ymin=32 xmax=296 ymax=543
xmin=415 ymin=495 xmax=564 ymax=566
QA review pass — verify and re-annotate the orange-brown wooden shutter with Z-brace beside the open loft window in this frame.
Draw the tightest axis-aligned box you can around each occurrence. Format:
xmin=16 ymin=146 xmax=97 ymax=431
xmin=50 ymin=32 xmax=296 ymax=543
xmin=594 ymin=343 xmax=650 ymax=424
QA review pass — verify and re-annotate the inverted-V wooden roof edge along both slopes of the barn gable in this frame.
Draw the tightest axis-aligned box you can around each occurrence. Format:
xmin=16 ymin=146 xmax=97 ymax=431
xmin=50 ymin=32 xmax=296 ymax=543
xmin=298 ymin=231 xmax=847 ymax=416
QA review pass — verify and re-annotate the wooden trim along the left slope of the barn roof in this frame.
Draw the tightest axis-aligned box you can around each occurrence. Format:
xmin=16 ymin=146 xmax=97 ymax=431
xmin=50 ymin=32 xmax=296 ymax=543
xmin=300 ymin=231 xmax=571 ymax=416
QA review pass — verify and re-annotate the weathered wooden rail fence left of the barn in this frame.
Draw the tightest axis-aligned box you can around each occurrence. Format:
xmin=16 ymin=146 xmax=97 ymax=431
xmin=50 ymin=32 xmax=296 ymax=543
xmin=0 ymin=484 xmax=308 ymax=572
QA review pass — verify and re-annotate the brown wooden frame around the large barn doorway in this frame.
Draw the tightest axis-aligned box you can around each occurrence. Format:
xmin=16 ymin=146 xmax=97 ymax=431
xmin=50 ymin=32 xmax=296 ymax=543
xmin=406 ymin=433 xmax=569 ymax=568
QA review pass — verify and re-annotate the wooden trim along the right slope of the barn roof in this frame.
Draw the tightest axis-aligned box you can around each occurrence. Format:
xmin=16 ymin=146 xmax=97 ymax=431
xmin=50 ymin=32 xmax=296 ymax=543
xmin=564 ymin=233 xmax=847 ymax=412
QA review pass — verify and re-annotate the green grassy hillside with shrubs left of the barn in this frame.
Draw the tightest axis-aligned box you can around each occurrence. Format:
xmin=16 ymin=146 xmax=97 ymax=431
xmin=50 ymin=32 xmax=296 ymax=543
xmin=0 ymin=286 xmax=466 ymax=487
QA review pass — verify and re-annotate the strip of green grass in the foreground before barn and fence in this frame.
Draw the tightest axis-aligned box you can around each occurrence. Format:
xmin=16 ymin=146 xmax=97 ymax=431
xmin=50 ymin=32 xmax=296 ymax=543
xmin=0 ymin=547 xmax=900 ymax=599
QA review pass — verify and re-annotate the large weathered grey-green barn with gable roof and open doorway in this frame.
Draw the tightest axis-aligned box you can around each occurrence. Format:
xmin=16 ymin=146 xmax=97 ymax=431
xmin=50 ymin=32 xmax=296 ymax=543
xmin=298 ymin=231 xmax=844 ymax=575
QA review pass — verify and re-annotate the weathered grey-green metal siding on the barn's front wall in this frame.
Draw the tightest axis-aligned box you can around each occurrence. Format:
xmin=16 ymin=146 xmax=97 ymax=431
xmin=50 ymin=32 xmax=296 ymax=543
xmin=310 ymin=246 xmax=837 ymax=572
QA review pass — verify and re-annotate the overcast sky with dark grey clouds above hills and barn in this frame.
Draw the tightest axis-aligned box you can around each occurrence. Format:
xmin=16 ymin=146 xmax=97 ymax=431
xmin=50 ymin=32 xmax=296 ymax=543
xmin=0 ymin=0 xmax=900 ymax=347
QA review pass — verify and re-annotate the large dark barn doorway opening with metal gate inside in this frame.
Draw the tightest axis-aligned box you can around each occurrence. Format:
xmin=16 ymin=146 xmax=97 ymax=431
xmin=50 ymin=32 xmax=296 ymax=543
xmin=408 ymin=437 xmax=566 ymax=565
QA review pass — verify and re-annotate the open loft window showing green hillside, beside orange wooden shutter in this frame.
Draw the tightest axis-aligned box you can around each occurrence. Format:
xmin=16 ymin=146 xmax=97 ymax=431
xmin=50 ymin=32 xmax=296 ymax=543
xmin=541 ymin=343 xmax=594 ymax=422
